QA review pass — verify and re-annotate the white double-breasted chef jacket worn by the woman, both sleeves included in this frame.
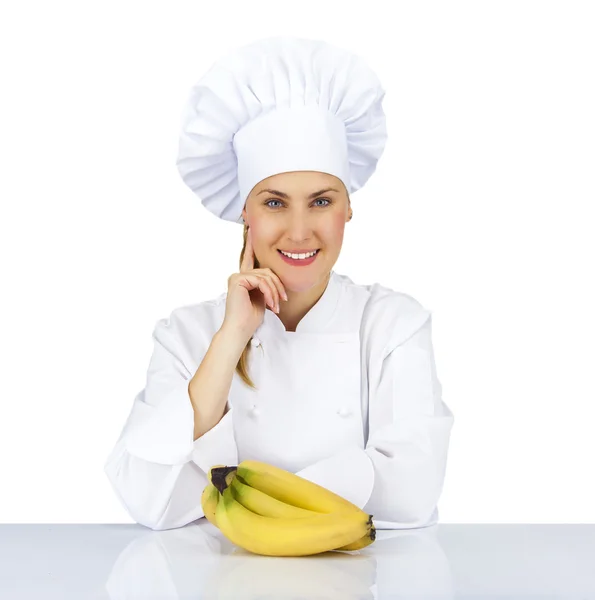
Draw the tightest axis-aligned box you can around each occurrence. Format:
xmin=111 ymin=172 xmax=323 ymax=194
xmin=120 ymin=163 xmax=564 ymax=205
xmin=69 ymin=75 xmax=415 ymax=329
xmin=104 ymin=270 xmax=454 ymax=530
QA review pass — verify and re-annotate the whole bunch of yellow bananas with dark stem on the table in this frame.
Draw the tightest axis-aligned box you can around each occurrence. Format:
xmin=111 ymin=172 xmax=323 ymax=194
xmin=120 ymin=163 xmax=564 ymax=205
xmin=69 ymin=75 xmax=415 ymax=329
xmin=201 ymin=460 xmax=376 ymax=556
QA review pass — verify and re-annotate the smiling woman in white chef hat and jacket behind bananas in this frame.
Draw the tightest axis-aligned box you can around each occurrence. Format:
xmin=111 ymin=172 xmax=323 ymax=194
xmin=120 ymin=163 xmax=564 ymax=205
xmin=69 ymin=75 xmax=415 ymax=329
xmin=105 ymin=36 xmax=454 ymax=530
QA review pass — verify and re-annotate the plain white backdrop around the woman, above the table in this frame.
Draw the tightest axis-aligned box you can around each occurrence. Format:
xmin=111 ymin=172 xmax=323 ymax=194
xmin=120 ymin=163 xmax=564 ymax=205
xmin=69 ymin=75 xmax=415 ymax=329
xmin=0 ymin=0 xmax=595 ymax=523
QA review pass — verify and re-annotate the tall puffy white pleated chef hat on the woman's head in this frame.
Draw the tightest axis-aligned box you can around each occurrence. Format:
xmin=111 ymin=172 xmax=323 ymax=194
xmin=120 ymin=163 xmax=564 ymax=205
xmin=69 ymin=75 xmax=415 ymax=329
xmin=176 ymin=36 xmax=387 ymax=223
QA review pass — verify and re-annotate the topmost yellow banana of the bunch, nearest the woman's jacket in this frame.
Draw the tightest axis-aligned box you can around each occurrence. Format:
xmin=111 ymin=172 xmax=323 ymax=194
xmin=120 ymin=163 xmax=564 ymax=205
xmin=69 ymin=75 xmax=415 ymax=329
xmin=237 ymin=460 xmax=366 ymax=515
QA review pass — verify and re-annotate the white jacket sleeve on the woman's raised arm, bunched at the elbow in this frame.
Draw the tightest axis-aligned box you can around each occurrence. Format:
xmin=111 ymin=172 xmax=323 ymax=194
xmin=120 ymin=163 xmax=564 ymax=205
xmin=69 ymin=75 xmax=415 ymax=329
xmin=104 ymin=319 xmax=238 ymax=530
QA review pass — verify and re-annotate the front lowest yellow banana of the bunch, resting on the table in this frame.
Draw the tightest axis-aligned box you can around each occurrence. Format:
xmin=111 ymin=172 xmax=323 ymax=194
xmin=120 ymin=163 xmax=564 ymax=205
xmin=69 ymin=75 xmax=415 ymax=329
xmin=215 ymin=485 xmax=373 ymax=556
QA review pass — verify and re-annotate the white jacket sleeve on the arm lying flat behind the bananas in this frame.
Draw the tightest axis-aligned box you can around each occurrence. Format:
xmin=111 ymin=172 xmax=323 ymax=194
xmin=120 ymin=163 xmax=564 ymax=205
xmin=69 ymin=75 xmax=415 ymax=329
xmin=297 ymin=311 xmax=454 ymax=529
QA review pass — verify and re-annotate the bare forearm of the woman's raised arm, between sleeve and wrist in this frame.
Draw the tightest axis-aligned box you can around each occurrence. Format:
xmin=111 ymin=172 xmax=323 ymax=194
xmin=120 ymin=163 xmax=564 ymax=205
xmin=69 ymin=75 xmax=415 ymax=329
xmin=188 ymin=327 xmax=250 ymax=441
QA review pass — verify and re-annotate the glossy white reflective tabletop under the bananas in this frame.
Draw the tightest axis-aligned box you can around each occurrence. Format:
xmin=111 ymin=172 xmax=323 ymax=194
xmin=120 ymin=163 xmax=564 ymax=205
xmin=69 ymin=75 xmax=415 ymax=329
xmin=0 ymin=518 xmax=595 ymax=600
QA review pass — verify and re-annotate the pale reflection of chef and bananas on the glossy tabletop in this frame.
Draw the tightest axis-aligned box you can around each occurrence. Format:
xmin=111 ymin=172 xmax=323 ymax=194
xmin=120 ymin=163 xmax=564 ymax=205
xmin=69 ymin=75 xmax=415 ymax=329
xmin=96 ymin=519 xmax=454 ymax=600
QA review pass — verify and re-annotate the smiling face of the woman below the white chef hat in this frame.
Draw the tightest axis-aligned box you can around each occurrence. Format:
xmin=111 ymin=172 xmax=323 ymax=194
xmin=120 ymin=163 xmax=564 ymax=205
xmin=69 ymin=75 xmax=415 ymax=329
xmin=242 ymin=171 xmax=351 ymax=292
